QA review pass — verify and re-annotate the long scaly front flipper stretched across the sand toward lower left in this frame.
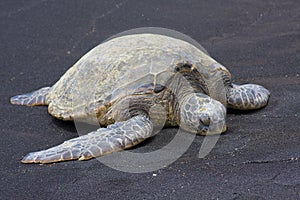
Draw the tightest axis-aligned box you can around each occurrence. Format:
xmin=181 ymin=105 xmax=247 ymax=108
xmin=22 ymin=115 xmax=153 ymax=163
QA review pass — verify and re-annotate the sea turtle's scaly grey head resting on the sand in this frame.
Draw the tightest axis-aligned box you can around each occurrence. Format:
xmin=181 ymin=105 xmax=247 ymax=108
xmin=180 ymin=93 xmax=226 ymax=135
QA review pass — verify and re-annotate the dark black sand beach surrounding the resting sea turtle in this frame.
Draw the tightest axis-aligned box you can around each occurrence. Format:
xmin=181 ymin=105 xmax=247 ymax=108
xmin=0 ymin=0 xmax=300 ymax=199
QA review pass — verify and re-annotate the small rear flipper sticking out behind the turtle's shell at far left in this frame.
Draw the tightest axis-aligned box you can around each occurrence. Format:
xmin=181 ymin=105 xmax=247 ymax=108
xmin=10 ymin=87 xmax=50 ymax=106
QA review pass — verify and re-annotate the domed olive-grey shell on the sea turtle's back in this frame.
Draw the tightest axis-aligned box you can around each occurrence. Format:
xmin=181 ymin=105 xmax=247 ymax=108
xmin=47 ymin=34 xmax=230 ymax=120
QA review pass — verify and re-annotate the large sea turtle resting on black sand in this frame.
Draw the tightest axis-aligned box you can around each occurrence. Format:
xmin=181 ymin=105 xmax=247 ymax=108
xmin=10 ymin=33 xmax=270 ymax=163
